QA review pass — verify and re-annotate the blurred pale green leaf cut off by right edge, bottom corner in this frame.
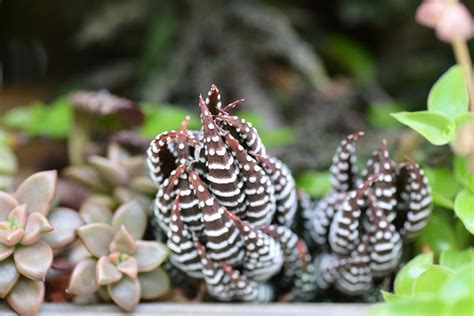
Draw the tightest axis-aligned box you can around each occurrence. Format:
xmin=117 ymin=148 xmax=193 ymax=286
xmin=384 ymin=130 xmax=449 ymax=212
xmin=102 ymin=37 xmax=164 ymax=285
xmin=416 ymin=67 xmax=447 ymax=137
xmin=439 ymin=263 xmax=474 ymax=302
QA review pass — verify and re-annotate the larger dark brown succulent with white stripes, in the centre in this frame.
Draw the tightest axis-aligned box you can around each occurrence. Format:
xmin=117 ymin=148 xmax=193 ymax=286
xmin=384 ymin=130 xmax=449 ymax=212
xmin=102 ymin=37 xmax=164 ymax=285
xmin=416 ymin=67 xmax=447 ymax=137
xmin=148 ymin=85 xmax=314 ymax=301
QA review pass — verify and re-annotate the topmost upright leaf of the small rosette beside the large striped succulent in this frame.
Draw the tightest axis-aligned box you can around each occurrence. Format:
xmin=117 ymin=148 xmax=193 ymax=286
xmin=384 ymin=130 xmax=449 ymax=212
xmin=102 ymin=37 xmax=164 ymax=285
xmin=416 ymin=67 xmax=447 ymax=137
xmin=112 ymin=200 xmax=147 ymax=240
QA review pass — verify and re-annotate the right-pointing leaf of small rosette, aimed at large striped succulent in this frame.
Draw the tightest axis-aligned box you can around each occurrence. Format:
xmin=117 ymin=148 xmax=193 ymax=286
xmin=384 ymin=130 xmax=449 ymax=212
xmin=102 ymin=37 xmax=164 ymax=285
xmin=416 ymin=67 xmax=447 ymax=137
xmin=133 ymin=240 xmax=169 ymax=272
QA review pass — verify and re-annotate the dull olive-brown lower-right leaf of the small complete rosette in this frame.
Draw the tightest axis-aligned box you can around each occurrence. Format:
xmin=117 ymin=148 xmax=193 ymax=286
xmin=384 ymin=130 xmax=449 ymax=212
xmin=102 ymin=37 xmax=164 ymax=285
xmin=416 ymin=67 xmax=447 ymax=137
xmin=138 ymin=268 xmax=171 ymax=300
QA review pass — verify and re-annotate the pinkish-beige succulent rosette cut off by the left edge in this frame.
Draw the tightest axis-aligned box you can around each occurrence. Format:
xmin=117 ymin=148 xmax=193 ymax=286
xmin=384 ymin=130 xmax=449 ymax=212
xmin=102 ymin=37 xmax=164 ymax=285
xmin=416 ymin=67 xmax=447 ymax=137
xmin=0 ymin=171 xmax=82 ymax=314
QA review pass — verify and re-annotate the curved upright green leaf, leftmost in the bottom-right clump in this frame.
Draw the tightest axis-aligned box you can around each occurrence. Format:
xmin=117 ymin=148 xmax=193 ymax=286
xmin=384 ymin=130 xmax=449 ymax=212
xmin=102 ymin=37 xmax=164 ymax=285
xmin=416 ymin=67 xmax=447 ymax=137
xmin=394 ymin=252 xmax=433 ymax=296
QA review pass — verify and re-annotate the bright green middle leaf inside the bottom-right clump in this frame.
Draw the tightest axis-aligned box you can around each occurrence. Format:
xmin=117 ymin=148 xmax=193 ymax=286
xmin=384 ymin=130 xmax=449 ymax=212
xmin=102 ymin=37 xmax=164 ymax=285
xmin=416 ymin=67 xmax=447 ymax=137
xmin=413 ymin=265 xmax=454 ymax=296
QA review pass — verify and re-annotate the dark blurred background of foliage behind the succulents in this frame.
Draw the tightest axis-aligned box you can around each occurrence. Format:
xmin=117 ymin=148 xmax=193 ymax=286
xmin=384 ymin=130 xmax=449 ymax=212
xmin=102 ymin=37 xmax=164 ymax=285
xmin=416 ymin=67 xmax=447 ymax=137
xmin=0 ymin=0 xmax=466 ymax=181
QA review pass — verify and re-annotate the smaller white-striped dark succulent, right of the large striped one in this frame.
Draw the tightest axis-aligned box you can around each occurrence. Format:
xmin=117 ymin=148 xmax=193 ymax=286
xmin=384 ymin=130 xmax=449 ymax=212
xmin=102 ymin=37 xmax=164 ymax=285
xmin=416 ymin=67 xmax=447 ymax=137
xmin=304 ymin=132 xmax=432 ymax=296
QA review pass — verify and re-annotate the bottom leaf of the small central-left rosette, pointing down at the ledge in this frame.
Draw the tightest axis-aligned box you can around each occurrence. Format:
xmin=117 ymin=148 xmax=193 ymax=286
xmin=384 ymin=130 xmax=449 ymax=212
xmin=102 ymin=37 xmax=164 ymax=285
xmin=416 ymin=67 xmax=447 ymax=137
xmin=107 ymin=276 xmax=141 ymax=312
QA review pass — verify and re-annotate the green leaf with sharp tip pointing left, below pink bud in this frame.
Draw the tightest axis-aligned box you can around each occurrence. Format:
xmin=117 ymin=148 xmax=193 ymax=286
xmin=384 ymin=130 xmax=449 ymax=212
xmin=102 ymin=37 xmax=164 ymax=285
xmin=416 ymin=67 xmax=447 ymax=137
xmin=392 ymin=111 xmax=456 ymax=146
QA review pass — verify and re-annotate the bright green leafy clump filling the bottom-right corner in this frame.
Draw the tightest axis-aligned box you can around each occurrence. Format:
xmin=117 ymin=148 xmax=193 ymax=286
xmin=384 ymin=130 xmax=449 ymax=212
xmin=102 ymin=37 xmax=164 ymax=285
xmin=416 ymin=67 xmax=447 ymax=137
xmin=369 ymin=248 xmax=474 ymax=316
